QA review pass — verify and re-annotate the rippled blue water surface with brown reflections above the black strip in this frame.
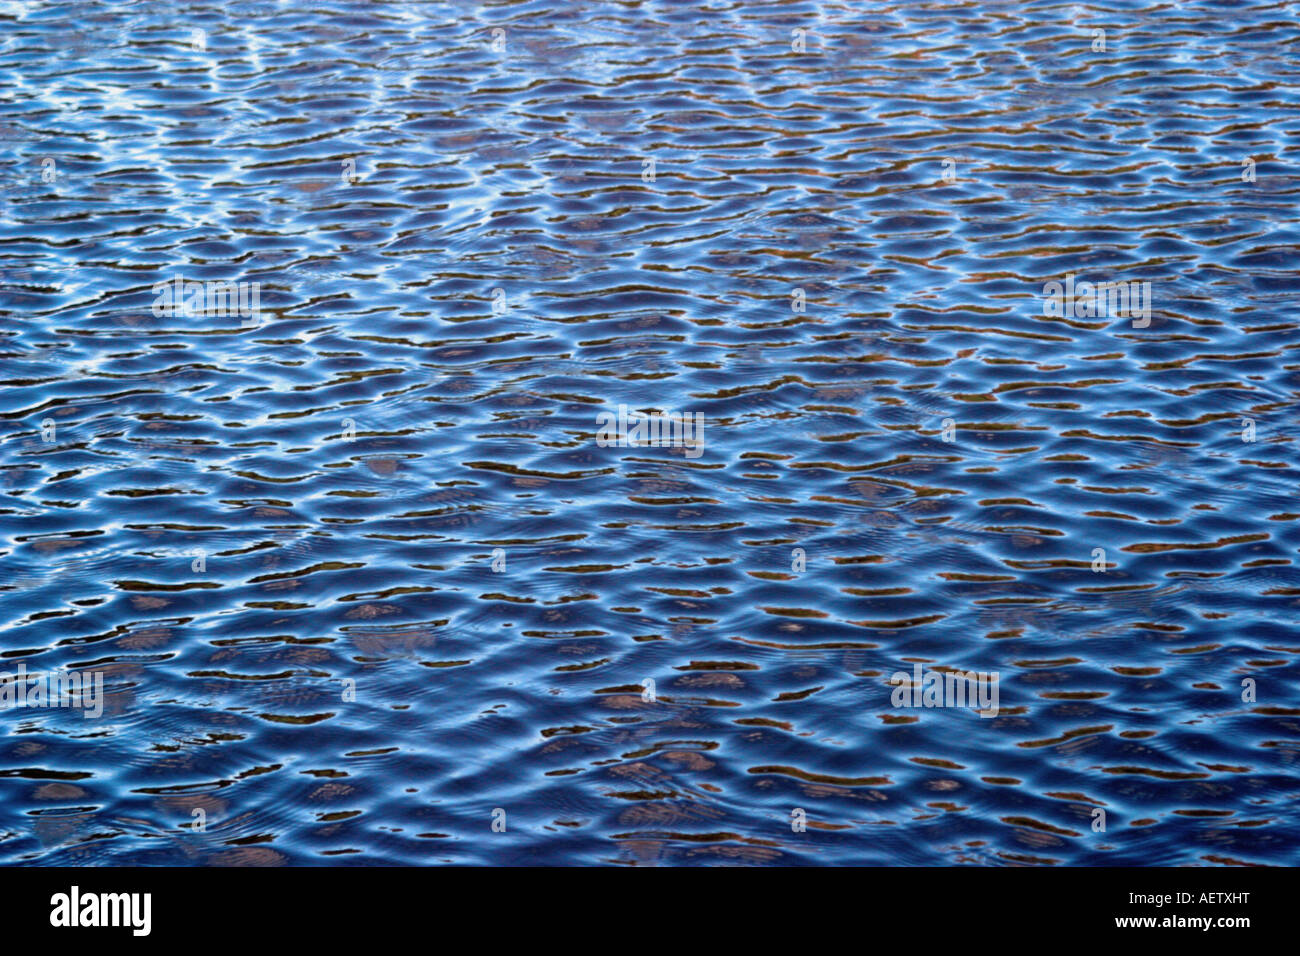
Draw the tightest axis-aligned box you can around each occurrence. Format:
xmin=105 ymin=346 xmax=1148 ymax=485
xmin=0 ymin=0 xmax=1300 ymax=865
